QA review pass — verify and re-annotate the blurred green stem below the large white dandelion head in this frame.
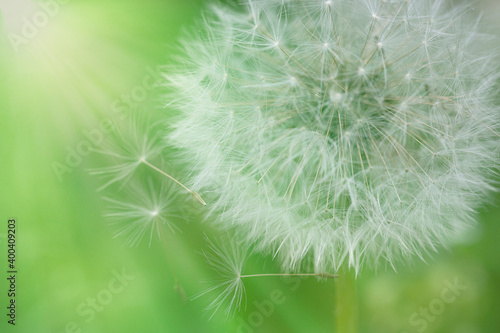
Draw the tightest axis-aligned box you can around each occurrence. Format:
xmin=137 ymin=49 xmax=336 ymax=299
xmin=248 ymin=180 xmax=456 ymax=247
xmin=334 ymin=269 xmax=358 ymax=333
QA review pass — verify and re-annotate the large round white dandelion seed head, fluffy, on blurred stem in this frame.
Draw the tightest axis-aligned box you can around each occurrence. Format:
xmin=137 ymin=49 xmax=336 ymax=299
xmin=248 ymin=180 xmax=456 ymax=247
xmin=168 ymin=0 xmax=500 ymax=271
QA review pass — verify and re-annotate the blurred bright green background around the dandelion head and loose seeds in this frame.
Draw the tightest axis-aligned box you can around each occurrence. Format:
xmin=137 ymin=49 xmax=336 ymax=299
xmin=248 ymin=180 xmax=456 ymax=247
xmin=0 ymin=0 xmax=500 ymax=333
